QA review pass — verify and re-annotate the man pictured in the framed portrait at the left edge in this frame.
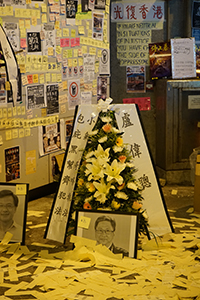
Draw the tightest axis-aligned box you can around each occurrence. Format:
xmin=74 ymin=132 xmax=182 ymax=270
xmin=0 ymin=190 xmax=22 ymax=241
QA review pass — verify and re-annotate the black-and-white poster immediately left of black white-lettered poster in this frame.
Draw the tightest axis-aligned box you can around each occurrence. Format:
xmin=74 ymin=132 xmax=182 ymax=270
xmin=26 ymin=84 xmax=46 ymax=109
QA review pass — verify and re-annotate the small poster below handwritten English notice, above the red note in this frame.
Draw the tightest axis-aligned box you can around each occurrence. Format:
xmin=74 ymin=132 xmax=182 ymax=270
xmin=126 ymin=66 xmax=146 ymax=93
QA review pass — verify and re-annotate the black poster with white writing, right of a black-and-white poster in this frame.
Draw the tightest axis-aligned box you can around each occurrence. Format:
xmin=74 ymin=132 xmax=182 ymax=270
xmin=46 ymin=84 xmax=59 ymax=115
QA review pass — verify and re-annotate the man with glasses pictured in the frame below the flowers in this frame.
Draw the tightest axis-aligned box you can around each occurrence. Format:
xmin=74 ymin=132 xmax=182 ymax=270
xmin=94 ymin=216 xmax=129 ymax=256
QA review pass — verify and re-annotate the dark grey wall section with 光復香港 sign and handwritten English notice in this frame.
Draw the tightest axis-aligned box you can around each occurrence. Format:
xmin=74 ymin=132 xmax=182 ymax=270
xmin=110 ymin=0 xmax=166 ymax=159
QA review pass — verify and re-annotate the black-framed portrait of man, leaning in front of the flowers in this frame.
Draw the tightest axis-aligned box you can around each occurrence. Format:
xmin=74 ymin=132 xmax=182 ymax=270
xmin=75 ymin=210 xmax=138 ymax=258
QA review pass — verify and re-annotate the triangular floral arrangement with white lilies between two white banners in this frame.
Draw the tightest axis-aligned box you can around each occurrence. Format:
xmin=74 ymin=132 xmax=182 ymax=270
xmin=72 ymin=106 xmax=148 ymax=234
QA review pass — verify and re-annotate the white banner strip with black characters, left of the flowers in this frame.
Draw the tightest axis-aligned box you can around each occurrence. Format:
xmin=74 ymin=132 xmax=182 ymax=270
xmin=45 ymin=105 xmax=99 ymax=243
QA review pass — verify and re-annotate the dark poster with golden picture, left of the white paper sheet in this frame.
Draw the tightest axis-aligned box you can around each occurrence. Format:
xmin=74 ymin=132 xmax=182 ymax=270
xmin=149 ymin=42 xmax=172 ymax=79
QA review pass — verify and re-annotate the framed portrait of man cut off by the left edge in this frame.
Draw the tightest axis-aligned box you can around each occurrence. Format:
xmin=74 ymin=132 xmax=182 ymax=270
xmin=0 ymin=183 xmax=29 ymax=245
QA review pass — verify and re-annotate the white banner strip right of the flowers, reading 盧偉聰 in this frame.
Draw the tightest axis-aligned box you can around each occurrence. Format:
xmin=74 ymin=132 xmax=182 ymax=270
xmin=114 ymin=104 xmax=172 ymax=236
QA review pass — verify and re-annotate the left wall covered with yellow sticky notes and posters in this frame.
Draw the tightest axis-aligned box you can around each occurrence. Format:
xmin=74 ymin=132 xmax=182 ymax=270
xmin=0 ymin=0 xmax=110 ymax=189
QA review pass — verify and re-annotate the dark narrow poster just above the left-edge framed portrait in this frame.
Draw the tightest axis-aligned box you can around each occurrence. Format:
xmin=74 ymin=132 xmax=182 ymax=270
xmin=5 ymin=146 xmax=20 ymax=182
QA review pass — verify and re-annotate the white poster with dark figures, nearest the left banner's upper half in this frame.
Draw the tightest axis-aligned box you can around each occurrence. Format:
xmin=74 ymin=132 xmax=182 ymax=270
xmin=38 ymin=122 xmax=61 ymax=156
